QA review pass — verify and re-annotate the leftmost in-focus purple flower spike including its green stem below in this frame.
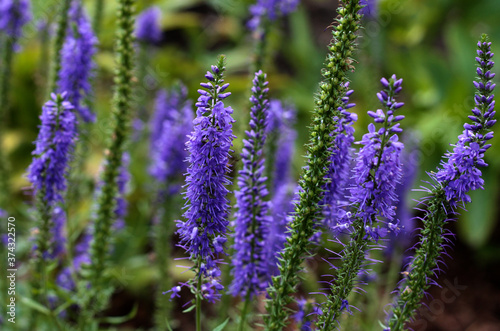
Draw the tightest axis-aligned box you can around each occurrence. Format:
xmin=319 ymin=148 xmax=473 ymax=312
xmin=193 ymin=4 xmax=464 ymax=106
xmin=28 ymin=94 xmax=76 ymax=303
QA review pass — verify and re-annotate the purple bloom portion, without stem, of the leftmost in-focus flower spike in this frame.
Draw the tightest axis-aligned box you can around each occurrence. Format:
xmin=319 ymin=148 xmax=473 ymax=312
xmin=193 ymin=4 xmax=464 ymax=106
xmin=28 ymin=93 xmax=77 ymax=205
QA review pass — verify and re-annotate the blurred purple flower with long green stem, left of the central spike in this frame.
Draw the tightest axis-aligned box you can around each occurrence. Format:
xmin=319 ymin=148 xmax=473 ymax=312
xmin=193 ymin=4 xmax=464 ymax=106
xmin=149 ymin=86 xmax=193 ymax=330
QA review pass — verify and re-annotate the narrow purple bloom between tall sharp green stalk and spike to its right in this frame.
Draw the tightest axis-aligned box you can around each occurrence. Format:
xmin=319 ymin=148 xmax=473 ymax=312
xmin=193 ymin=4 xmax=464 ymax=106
xmin=321 ymin=83 xmax=358 ymax=229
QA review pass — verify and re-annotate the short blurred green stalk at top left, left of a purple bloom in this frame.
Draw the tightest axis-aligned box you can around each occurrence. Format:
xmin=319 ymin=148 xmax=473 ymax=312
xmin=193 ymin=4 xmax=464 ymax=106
xmin=46 ymin=0 xmax=71 ymax=100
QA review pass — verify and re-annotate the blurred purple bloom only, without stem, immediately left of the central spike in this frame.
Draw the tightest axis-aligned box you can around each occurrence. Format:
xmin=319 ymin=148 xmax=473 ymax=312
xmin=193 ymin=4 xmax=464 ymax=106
xmin=149 ymin=86 xmax=193 ymax=184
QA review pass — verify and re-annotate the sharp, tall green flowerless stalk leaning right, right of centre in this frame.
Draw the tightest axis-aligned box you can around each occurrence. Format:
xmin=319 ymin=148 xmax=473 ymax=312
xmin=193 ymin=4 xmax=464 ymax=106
xmin=264 ymin=0 xmax=361 ymax=331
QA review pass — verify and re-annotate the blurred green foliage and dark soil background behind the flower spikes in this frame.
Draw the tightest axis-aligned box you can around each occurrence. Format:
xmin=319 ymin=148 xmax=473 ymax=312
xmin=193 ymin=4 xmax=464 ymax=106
xmin=4 ymin=0 xmax=500 ymax=331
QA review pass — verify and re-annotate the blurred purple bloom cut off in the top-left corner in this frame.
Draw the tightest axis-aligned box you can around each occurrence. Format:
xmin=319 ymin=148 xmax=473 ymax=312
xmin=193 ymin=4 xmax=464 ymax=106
xmin=0 ymin=0 xmax=31 ymax=47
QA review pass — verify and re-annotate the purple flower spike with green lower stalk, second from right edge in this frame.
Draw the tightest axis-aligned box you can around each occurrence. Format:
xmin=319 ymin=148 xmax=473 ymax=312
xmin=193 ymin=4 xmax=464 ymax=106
xmin=318 ymin=75 xmax=404 ymax=330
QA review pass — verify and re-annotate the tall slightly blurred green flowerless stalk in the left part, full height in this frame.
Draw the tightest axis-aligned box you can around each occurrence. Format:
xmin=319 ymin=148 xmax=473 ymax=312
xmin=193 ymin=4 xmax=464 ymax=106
xmin=79 ymin=0 xmax=135 ymax=329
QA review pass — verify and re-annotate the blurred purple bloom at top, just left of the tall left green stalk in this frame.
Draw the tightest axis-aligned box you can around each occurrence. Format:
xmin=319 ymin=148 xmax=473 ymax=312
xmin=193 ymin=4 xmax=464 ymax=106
xmin=58 ymin=1 xmax=97 ymax=122
